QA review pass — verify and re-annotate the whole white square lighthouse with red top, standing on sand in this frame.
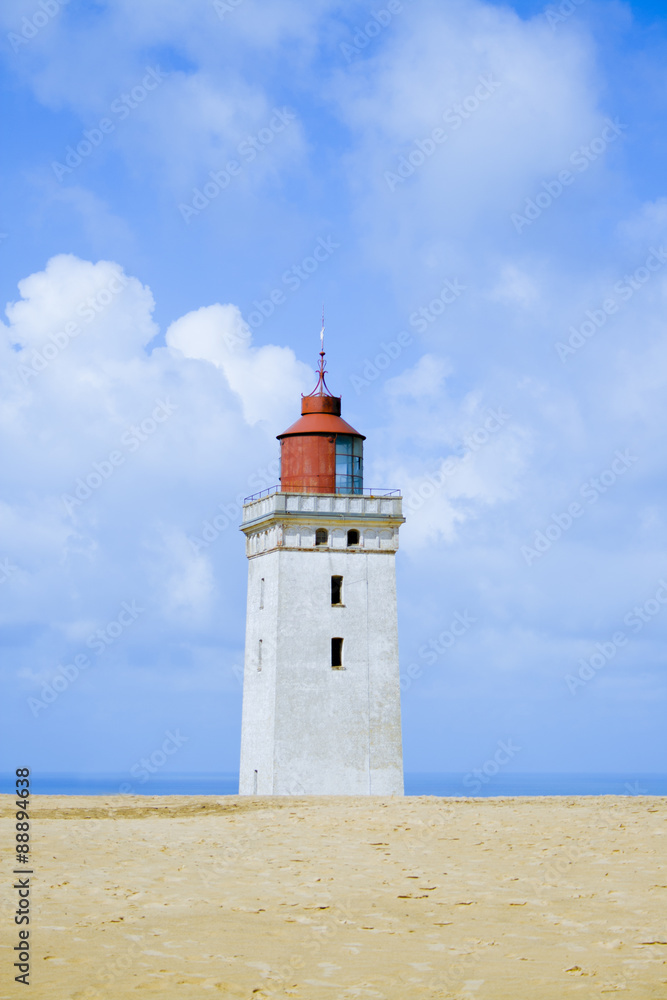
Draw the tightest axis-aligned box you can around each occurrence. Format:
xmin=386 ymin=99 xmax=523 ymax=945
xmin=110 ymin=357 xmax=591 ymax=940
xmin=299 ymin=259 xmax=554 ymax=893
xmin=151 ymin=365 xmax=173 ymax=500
xmin=239 ymin=344 xmax=405 ymax=795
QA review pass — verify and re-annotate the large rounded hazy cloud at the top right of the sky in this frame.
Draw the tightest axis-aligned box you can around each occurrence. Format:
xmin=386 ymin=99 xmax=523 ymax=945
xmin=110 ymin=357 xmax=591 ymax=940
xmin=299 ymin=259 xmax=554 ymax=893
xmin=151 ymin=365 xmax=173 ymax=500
xmin=330 ymin=0 xmax=613 ymax=296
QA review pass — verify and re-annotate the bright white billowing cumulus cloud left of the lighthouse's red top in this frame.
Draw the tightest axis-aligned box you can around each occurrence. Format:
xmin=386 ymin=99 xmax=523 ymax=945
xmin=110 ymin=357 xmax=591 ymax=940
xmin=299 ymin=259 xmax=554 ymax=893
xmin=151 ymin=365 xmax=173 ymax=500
xmin=0 ymin=254 xmax=312 ymax=700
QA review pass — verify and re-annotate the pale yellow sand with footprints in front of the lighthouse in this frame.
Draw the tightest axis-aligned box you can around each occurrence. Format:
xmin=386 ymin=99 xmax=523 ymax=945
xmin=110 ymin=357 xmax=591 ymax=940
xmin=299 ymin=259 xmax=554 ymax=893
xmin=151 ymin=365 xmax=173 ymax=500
xmin=0 ymin=796 xmax=667 ymax=1000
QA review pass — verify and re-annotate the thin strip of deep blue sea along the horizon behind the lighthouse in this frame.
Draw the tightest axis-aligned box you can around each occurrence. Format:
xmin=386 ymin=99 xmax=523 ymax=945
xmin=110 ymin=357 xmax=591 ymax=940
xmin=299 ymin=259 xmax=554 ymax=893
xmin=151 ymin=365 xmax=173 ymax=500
xmin=2 ymin=771 xmax=667 ymax=798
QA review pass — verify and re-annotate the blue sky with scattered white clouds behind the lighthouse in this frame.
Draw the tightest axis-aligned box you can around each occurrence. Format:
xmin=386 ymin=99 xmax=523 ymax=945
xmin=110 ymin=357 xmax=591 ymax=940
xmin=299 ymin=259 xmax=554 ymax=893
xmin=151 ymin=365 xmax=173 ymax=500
xmin=0 ymin=0 xmax=667 ymax=773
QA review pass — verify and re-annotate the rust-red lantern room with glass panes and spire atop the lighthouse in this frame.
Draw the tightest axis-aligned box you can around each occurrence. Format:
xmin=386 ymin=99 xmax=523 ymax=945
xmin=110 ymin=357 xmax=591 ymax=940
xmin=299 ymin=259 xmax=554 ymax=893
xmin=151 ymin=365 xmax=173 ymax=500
xmin=278 ymin=349 xmax=365 ymax=493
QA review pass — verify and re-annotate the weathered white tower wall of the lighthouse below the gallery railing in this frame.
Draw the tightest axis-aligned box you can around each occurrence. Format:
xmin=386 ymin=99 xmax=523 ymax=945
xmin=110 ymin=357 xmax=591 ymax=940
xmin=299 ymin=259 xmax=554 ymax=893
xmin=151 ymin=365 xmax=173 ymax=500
xmin=239 ymin=505 xmax=403 ymax=795
